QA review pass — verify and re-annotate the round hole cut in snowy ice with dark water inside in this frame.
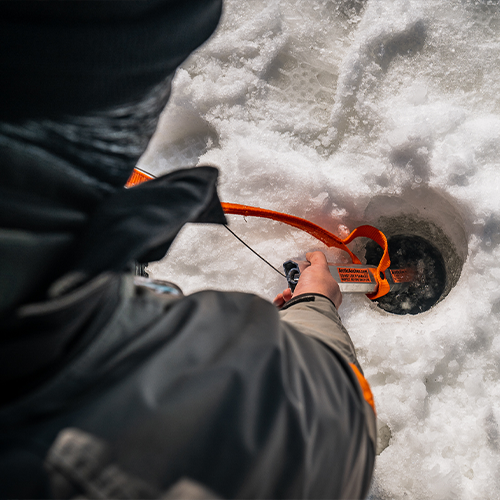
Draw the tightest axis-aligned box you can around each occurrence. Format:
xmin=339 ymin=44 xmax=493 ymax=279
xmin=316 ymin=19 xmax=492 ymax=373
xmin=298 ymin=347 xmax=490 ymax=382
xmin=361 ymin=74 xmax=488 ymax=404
xmin=365 ymin=188 xmax=467 ymax=314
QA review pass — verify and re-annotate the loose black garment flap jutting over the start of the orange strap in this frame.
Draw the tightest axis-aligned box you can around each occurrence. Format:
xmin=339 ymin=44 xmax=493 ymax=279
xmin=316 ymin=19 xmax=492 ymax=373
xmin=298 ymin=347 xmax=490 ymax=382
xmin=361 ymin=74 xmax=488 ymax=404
xmin=69 ymin=167 xmax=226 ymax=277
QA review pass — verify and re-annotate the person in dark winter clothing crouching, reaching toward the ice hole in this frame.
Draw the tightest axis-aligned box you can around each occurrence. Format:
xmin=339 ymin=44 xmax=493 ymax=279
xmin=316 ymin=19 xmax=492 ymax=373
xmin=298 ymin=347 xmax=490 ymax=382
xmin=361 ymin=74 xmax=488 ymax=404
xmin=0 ymin=0 xmax=375 ymax=498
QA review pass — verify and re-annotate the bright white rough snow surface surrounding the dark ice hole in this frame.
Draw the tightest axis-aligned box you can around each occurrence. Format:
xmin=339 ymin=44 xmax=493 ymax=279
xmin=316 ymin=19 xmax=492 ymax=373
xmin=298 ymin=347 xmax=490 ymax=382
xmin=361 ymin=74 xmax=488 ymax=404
xmin=140 ymin=0 xmax=500 ymax=500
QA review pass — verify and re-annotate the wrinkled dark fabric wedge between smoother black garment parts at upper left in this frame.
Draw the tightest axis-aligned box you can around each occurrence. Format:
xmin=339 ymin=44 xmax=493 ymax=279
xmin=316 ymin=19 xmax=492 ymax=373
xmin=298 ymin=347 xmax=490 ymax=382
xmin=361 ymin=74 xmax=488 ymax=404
xmin=0 ymin=77 xmax=173 ymax=188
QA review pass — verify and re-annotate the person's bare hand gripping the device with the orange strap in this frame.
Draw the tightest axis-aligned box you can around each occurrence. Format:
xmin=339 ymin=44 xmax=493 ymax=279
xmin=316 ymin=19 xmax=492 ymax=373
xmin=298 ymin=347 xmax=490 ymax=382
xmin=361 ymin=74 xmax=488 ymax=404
xmin=273 ymin=251 xmax=342 ymax=309
